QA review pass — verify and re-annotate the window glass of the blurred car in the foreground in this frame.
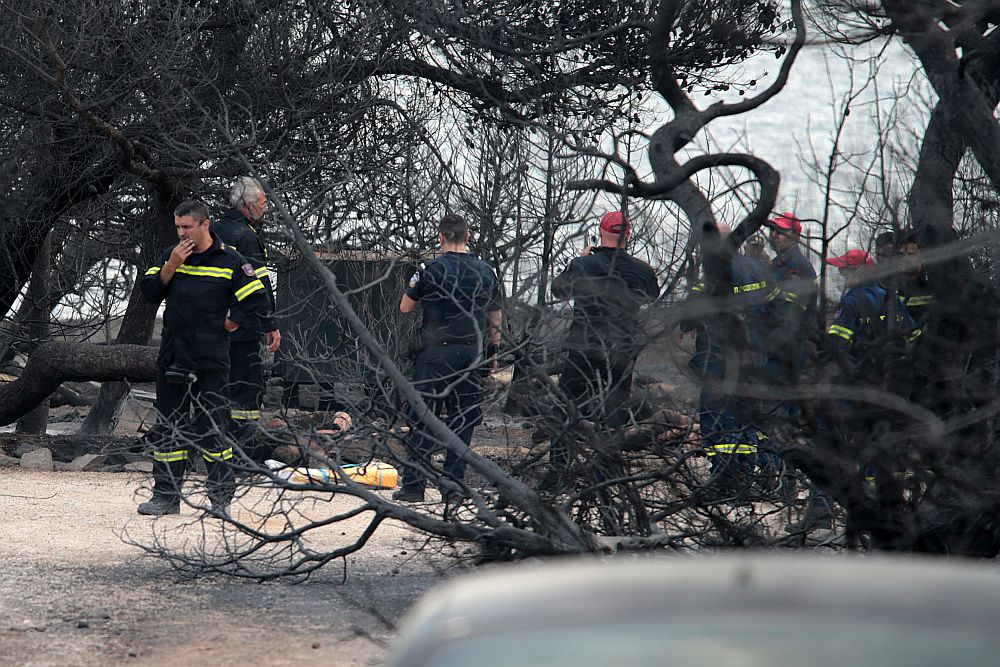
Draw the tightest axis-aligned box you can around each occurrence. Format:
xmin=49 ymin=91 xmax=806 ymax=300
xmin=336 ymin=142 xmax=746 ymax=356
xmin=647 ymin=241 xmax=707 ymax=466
xmin=425 ymin=617 xmax=1000 ymax=667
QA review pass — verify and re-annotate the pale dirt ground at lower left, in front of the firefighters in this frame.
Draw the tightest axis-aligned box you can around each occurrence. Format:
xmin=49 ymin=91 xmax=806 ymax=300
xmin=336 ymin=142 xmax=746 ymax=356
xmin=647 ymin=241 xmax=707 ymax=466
xmin=0 ymin=468 xmax=441 ymax=667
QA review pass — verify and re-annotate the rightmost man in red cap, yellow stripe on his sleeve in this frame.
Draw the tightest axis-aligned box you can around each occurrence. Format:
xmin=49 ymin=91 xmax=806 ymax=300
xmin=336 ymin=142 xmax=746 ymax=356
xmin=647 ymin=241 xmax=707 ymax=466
xmin=785 ymin=249 xmax=920 ymax=533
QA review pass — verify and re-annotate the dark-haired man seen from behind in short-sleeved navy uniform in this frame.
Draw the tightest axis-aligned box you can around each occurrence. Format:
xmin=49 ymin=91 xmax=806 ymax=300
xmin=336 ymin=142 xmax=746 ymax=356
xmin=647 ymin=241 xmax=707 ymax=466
xmin=393 ymin=214 xmax=502 ymax=502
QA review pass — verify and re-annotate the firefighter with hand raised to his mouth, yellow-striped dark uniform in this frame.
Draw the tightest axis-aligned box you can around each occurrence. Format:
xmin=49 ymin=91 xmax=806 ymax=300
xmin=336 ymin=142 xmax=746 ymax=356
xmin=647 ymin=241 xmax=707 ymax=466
xmin=138 ymin=201 xmax=270 ymax=515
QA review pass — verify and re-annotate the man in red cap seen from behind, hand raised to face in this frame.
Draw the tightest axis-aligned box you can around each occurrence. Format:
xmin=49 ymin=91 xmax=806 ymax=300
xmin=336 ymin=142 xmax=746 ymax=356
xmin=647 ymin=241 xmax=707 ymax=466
xmin=543 ymin=211 xmax=660 ymax=490
